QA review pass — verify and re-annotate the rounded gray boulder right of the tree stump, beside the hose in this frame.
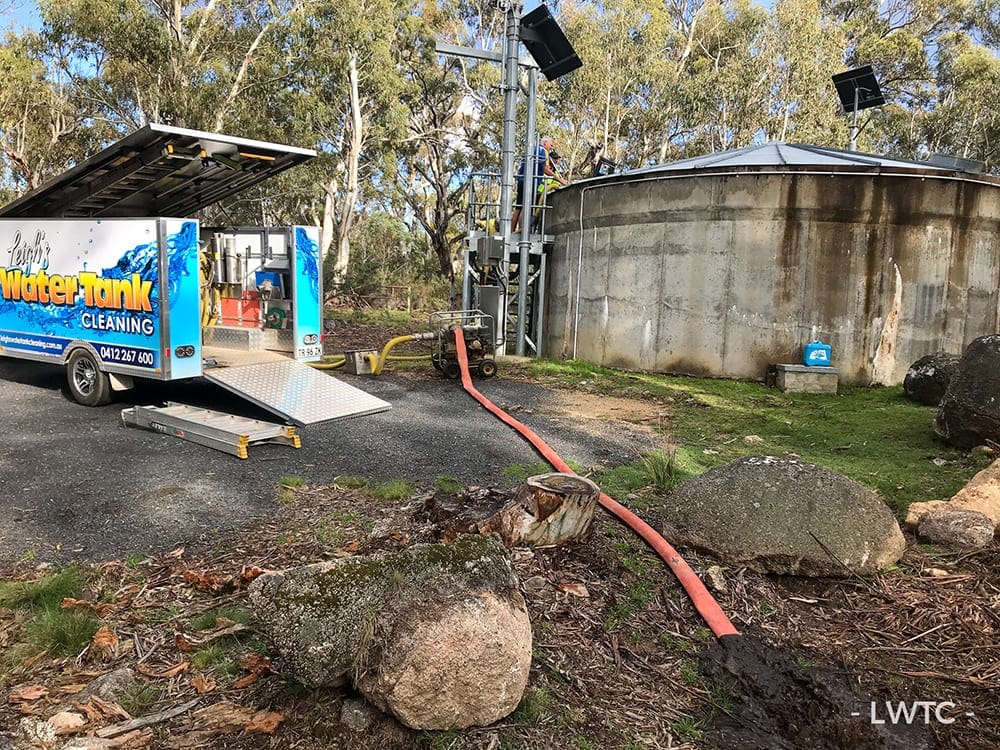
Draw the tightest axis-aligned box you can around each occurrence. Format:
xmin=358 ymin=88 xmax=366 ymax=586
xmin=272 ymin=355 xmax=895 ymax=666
xmin=664 ymin=456 xmax=906 ymax=576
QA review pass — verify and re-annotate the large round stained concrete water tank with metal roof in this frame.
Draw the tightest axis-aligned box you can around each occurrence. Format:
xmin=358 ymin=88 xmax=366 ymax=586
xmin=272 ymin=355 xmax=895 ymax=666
xmin=542 ymin=143 xmax=1000 ymax=385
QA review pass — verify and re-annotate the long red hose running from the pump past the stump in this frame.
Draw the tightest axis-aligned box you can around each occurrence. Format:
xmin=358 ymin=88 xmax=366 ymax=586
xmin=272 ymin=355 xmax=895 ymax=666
xmin=454 ymin=326 xmax=740 ymax=638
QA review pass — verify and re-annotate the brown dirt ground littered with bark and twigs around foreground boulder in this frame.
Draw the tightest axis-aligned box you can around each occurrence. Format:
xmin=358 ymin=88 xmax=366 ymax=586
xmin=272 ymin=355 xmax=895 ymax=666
xmin=0 ymin=314 xmax=1000 ymax=750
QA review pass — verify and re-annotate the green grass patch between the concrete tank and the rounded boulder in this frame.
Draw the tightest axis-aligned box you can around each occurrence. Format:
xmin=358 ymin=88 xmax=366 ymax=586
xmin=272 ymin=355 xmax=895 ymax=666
xmin=523 ymin=360 xmax=989 ymax=516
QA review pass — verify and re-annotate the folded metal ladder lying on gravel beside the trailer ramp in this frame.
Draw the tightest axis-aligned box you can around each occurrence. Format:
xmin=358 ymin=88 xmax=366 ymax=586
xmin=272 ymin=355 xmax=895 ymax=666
xmin=122 ymin=401 xmax=302 ymax=458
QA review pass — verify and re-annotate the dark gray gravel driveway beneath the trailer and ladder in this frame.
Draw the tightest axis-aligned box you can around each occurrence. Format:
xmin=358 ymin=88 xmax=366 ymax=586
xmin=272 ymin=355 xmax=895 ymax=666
xmin=0 ymin=359 xmax=650 ymax=565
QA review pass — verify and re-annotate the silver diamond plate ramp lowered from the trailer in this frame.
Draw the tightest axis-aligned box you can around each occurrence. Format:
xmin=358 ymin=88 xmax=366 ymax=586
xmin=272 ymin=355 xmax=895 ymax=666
xmin=203 ymin=359 xmax=391 ymax=426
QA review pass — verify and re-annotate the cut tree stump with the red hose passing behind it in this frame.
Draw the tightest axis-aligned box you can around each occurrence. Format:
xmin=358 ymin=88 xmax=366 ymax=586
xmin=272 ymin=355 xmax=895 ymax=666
xmin=479 ymin=473 xmax=601 ymax=547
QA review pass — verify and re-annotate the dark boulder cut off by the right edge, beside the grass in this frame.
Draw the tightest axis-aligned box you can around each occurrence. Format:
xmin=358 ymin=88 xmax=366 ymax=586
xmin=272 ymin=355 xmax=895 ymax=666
xmin=934 ymin=334 xmax=1000 ymax=448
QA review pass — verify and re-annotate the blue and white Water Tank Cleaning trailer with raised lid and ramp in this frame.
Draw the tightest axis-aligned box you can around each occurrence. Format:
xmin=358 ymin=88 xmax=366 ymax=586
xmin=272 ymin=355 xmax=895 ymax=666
xmin=0 ymin=125 xmax=389 ymax=425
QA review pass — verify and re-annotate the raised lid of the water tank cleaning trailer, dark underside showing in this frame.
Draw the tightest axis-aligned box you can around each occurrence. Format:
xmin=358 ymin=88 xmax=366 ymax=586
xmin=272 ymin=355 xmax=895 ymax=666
xmin=0 ymin=124 xmax=316 ymax=218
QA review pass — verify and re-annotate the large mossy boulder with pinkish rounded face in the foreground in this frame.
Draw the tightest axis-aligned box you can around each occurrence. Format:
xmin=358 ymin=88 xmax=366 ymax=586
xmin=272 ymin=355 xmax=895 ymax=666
xmin=249 ymin=535 xmax=531 ymax=729
